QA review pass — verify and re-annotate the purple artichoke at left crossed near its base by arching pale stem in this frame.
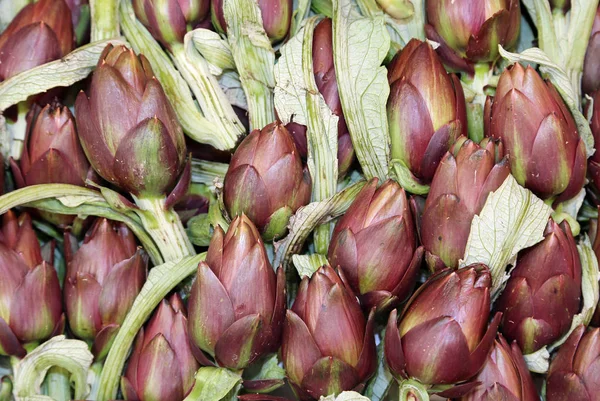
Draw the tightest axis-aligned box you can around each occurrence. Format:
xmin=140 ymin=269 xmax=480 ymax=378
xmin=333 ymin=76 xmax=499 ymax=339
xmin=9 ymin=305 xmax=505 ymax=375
xmin=10 ymin=102 xmax=96 ymax=227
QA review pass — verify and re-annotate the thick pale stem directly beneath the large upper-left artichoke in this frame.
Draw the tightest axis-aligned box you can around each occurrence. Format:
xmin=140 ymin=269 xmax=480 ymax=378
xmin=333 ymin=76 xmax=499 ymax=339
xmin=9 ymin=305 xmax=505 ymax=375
xmin=134 ymin=197 xmax=196 ymax=261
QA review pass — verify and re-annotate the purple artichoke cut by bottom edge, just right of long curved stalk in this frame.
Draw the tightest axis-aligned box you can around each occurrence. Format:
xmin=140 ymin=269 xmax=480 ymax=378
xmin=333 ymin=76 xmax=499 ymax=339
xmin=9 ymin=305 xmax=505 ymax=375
xmin=121 ymin=294 xmax=200 ymax=401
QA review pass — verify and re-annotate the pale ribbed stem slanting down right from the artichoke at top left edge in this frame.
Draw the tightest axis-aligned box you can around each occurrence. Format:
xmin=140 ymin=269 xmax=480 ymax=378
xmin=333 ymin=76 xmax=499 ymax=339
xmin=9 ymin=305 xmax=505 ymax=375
xmin=171 ymin=44 xmax=245 ymax=148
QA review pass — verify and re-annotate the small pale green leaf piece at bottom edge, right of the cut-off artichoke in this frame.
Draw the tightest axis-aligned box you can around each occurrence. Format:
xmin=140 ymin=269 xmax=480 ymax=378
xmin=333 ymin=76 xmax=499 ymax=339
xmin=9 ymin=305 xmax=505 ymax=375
xmin=184 ymin=366 xmax=242 ymax=401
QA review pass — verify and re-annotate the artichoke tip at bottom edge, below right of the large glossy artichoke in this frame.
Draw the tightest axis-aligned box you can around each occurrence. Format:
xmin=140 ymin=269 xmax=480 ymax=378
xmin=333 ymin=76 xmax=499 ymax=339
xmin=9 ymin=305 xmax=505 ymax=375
xmin=458 ymin=335 xmax=540 ymax=401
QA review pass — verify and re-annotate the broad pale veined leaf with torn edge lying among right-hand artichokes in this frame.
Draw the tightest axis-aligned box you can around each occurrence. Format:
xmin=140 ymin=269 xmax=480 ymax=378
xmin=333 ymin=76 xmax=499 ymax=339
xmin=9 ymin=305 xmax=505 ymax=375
xmin=460 ymin=175 xmax=552 ymax=299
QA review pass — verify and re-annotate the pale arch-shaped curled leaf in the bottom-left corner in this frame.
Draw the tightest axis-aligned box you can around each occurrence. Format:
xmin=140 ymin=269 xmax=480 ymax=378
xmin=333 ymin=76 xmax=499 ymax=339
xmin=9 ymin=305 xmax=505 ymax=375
xmin=13 ymin=335 xmax=94 ymax=401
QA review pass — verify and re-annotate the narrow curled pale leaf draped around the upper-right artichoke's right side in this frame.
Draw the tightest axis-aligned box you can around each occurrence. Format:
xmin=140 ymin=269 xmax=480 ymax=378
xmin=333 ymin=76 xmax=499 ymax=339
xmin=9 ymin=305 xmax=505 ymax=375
xmin=499 ymin=45 xmax=595 ymax=158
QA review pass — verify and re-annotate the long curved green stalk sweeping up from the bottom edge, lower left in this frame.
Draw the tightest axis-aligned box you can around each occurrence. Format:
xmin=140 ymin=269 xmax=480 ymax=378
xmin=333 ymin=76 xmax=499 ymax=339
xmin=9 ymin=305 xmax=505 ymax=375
xmin=96 ymin=253 xmax=206 ymax=401
